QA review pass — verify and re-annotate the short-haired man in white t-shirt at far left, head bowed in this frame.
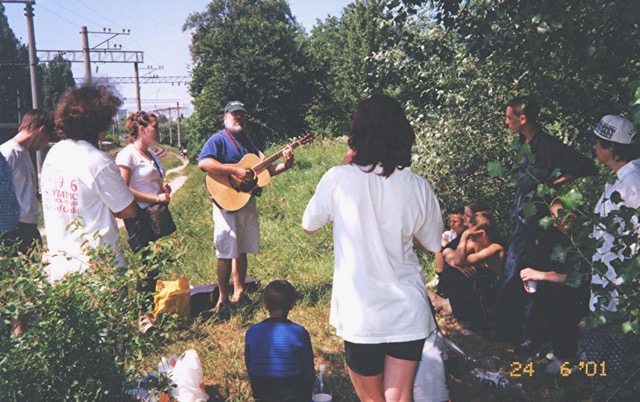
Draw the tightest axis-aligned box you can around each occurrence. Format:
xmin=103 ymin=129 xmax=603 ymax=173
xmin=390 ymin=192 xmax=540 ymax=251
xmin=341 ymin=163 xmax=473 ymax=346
xmin=0 ymin=109 xmax=55 ymax=254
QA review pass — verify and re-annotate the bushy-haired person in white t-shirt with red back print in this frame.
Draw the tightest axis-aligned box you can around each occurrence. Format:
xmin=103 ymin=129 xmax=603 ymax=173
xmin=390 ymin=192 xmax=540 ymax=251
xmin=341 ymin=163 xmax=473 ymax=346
xmin=42 ymin=85 xmax=136 ymax=282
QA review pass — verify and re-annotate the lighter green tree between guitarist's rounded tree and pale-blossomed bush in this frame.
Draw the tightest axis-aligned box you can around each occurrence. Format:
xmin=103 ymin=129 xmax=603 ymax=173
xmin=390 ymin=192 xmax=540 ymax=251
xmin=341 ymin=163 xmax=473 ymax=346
xmin=307 ymin=0 xmax=391 ymax=136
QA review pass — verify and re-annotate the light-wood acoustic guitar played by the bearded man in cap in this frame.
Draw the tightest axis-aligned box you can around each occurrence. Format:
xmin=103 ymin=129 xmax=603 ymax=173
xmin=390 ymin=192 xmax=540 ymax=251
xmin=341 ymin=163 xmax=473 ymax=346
xmin=204 ymin=132 xmax=316 ymax=211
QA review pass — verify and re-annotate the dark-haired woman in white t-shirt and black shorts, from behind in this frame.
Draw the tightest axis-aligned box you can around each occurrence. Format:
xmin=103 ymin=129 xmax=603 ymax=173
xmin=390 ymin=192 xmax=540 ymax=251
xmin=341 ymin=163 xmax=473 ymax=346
xmin=302 ymin=94 xmax=444 ymax=402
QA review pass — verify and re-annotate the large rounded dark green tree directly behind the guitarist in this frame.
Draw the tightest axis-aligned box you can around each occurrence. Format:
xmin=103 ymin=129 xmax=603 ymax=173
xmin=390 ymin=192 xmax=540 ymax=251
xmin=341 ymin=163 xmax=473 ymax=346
xmin=183 ymin=0 xmax=313 ymax=151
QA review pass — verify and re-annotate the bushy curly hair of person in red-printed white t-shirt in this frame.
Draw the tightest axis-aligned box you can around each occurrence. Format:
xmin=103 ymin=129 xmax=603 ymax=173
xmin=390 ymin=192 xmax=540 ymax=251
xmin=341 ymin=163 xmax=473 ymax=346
xmin=55 ymin=84 xmax=122 ymax=144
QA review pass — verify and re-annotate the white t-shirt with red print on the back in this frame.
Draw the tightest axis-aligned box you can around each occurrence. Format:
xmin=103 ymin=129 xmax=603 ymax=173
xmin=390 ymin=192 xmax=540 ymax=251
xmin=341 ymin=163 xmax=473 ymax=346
xmin=41 ymin=139 xmax=134 ymax=282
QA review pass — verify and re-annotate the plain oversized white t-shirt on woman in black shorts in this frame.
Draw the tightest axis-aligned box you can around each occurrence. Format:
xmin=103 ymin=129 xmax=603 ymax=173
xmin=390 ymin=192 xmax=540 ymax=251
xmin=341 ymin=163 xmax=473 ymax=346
xmin=302 ymin=165 xmax=444 ymax=344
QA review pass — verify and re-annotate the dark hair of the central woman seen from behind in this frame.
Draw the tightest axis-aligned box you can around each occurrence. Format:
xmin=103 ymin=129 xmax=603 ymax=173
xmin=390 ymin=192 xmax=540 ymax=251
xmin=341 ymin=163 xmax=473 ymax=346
xmin=348 ymin=94 xmax=416 ymax=177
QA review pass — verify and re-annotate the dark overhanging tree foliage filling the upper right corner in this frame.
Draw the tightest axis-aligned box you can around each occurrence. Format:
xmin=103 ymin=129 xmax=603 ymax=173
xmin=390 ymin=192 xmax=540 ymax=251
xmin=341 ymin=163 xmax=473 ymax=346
xmin=392 ymin=0 xmax=640 ymax=132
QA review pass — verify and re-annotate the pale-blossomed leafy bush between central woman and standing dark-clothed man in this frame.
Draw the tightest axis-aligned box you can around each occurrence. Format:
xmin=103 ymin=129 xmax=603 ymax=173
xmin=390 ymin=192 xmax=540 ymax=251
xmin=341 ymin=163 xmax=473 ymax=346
xmin=373 ymin=7 xmax=514 ymax=229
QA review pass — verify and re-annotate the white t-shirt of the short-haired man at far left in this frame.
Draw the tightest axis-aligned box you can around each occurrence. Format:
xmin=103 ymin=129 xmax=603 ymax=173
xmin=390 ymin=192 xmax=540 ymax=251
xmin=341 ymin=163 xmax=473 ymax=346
xmin=0 ymin=139 xmax=40 ymax=224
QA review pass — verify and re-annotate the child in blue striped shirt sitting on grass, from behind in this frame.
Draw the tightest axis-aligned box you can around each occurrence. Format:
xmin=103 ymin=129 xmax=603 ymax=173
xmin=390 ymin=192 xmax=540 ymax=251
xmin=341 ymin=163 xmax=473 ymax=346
xmin=244 ymin=280 xmax=314 ymax=402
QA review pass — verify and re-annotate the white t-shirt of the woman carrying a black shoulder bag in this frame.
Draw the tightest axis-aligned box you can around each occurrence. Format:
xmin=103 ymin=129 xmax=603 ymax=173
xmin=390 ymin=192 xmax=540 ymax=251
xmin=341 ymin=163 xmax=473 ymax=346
xmin=116 ymin=144 xmax=166 ymax=208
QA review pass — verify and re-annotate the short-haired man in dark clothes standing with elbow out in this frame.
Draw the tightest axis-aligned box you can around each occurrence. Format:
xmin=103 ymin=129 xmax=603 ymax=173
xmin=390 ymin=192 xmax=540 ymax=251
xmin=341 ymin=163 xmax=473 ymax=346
xmin=495 ymin=96 xmax=597 ymax=351
